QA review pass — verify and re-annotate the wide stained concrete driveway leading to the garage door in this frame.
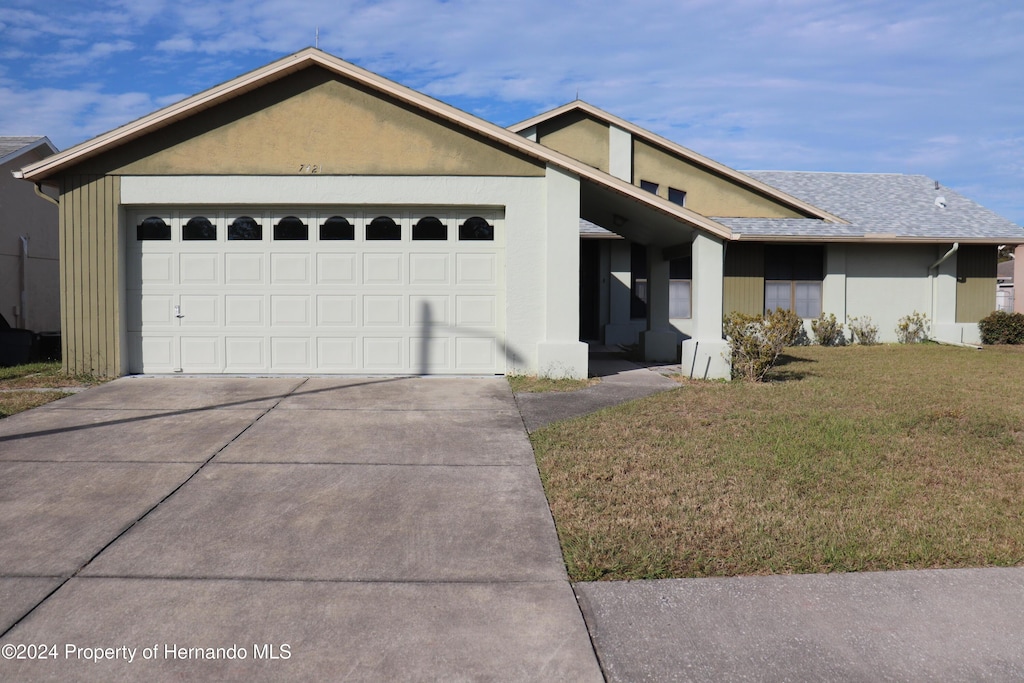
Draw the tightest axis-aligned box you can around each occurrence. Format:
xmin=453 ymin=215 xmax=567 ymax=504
xmin=0 ymin=378 xmax=602 ymax=681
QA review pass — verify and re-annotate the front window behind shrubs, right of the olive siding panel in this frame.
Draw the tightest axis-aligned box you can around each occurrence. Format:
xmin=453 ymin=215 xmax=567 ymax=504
xmin=765 ymin=245 xmax=824 ymax=318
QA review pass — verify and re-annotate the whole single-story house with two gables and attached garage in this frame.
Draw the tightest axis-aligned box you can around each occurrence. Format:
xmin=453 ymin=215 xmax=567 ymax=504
xmin=14 ymin=48 xmax=1024 ymax=377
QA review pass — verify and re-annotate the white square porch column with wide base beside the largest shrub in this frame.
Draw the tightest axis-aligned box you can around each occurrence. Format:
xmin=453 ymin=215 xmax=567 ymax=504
xmin=682 ymin=232 xmax=732 ymax=380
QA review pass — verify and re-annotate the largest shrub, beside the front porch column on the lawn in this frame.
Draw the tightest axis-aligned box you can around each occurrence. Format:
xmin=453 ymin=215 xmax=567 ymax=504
xmin=723 ymin=308 xmax=804 ymax=382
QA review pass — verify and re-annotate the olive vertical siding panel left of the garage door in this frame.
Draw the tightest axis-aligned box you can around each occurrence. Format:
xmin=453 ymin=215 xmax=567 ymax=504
xmin=59 ymin=175 xmax=123 ymax=377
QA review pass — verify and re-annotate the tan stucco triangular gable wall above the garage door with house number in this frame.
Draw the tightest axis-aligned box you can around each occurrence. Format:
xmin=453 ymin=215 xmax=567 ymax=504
xmin=71 ymin=68 xmax=545 ymax=177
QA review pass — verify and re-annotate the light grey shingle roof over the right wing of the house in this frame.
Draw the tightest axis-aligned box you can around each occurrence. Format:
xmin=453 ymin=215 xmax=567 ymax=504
xmin=733 ymin=171 xmax=1024 ymax=241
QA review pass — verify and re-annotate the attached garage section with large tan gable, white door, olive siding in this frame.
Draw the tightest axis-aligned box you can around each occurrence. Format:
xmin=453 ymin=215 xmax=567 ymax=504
xmin=23 ymin=48 xmax=598 ymax=377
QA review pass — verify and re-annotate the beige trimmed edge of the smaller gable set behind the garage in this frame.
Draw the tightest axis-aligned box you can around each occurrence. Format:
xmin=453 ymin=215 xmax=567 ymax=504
xmin=509 ymin=99 xmax=845 ymax=223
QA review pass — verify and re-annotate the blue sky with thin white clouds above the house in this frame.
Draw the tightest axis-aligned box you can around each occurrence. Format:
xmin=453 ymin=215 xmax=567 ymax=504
xmin=0 ymin=0 xmax=1024 ymax=224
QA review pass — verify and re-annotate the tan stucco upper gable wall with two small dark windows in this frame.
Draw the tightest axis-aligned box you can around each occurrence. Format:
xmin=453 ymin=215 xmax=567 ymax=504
xmin=633 ymin=139 xmax=801 ymax=218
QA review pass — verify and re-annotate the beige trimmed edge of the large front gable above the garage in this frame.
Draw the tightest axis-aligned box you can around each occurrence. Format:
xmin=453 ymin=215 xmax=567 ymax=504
xmin=18 ymin=47 xmax=731 ymax=239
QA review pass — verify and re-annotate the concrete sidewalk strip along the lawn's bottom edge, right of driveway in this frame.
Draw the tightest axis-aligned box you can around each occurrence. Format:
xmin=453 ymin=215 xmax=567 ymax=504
xmin=575 ymin=567 xmax=1024 ymax=683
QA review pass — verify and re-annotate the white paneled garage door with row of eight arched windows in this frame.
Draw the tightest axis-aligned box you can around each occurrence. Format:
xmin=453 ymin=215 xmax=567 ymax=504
xmin=126 ymin=207 xmax=505 ymax=374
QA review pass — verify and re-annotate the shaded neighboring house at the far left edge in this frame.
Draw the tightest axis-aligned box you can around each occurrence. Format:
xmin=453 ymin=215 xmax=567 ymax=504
xmin=0 ymin=136 xmax=60 ymax=332
